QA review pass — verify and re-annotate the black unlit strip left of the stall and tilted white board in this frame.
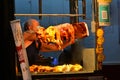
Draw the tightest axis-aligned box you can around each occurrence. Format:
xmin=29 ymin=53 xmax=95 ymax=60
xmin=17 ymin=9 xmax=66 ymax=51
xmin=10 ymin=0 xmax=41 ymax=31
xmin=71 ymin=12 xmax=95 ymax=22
xmin=0 ymin=0 xmax=16 ymax=80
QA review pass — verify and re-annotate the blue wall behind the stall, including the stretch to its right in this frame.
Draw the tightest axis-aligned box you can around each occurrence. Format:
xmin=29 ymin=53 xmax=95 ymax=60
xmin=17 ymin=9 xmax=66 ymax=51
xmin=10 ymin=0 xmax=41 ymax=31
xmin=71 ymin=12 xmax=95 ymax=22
xmin=15 ymin=0 xmax=120 ymax=64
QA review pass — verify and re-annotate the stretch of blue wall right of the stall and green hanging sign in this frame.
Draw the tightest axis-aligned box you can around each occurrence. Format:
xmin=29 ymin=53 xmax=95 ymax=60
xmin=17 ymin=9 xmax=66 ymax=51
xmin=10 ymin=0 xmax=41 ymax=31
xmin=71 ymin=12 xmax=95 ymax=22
xmin=104 ymin=0 xmax=120 ymax=64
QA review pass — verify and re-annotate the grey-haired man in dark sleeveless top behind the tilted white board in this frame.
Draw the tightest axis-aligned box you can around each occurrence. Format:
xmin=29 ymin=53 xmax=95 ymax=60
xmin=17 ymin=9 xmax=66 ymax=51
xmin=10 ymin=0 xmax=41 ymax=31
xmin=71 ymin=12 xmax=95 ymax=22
xmin=23 ymin=19 xmax=41 ymax=65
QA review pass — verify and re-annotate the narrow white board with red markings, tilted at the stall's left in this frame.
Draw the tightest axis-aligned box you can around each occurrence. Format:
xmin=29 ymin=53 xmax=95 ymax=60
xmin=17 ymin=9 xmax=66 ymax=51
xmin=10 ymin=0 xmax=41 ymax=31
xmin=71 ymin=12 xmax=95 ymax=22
xmin=10 ymin=20 xmax=32 ymax=80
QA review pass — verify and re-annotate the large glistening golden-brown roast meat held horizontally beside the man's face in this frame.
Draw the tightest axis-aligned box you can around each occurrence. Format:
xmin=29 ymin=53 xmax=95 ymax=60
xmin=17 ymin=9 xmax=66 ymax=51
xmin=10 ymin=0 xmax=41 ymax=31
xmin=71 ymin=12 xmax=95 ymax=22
xmin=37 ymin=22 xmax=89 ymax=51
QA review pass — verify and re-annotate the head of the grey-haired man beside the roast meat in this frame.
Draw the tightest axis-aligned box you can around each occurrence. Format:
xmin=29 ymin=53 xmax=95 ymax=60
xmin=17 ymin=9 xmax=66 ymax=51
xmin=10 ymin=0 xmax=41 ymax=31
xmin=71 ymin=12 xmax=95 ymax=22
xmin=24 ymin=19 xmax=40 ymax=32
